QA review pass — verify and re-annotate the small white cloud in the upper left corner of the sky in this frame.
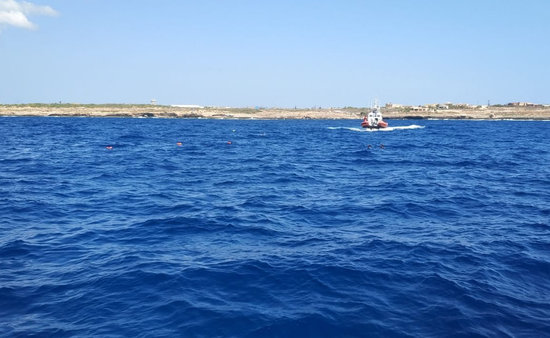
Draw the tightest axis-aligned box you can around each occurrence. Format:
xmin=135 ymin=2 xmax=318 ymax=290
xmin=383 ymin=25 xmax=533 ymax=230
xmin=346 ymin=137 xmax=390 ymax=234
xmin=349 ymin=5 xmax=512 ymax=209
xmin=0 ymin=0 xmax=57 ymax=29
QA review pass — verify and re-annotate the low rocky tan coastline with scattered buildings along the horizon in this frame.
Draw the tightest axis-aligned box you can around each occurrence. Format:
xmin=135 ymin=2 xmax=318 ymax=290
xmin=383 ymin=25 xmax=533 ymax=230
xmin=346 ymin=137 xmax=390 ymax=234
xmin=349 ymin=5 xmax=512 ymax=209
xmin=0 ymin=102 xmax=550 ymax=120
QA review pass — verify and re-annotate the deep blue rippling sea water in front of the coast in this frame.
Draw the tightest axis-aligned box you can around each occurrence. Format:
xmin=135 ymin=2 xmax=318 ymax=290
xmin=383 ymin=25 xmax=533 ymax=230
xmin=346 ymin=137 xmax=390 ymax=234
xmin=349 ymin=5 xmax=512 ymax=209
xmin=0 ymin=117 xmax=550 ymax=337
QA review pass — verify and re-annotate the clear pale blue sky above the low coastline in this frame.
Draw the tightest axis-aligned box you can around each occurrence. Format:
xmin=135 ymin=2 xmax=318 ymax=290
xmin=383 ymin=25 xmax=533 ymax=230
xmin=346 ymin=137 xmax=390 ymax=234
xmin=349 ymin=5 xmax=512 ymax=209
xmin=0 ymin=0 xmax=550 ymax=107
